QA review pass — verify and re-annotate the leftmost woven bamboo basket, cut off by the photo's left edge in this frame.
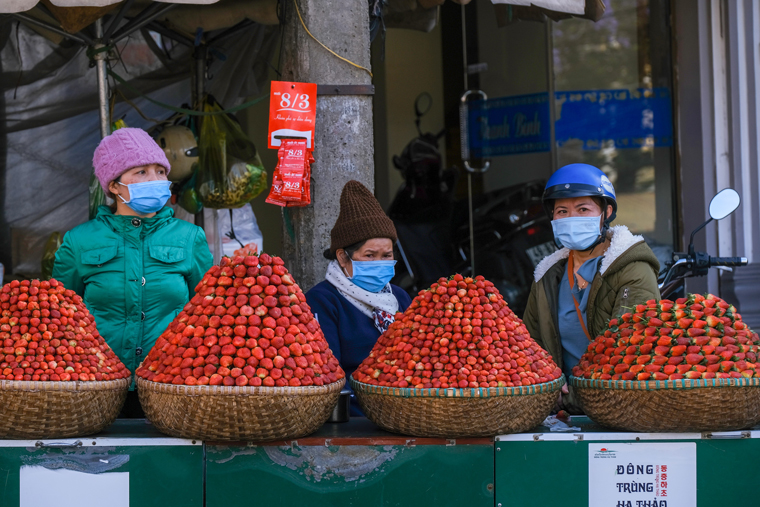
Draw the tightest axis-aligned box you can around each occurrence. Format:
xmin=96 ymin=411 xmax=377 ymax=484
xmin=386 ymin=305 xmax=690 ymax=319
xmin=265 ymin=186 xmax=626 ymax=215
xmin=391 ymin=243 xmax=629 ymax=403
xmin=0 ymin=379 xmax=130 ymax=440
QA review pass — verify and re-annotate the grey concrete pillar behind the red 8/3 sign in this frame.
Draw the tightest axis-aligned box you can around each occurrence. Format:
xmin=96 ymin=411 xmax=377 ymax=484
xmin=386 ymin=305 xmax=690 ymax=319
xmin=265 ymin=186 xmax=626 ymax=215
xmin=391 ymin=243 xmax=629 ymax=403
xmin=280 ymin=0 xmax=374 ymax=290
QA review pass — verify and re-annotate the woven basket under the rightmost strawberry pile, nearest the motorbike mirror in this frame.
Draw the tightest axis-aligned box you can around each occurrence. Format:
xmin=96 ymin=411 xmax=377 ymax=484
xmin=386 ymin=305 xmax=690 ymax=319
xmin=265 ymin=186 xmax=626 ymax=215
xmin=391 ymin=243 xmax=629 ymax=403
xmin=570 ymin=377 xmax=760 ymax=432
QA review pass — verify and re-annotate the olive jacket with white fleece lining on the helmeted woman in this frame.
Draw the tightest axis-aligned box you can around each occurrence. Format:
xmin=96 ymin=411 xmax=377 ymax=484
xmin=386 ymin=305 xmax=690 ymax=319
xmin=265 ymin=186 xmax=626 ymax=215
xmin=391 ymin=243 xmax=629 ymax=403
xmin=523 ymin=225 xmax=660 ymax=374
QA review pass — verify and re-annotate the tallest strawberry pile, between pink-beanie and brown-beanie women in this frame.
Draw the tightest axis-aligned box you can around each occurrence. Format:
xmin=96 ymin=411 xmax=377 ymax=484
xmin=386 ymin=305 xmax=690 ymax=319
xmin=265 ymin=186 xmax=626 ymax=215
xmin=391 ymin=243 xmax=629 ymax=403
xmin=137 ymin=253 xmax=345 ymax=387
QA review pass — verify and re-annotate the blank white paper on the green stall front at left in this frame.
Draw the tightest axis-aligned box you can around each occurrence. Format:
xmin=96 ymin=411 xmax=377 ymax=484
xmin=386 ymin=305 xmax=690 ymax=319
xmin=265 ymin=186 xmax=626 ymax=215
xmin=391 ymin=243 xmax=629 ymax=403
xmin=19 ymin=466 xmax=129 ymax=507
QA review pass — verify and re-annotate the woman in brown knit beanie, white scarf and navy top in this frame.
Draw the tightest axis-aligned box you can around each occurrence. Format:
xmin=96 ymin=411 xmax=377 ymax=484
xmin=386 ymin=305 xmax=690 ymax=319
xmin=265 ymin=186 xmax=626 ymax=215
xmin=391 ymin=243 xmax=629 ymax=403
xmin=306 ymin=180 xmax=412 ymax=412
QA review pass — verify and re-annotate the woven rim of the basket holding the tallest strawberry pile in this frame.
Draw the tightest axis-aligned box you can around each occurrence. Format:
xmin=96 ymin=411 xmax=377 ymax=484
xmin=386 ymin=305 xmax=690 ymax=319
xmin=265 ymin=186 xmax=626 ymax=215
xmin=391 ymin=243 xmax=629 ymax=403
xmin=137 ymin=377 xmax=346 ymax=396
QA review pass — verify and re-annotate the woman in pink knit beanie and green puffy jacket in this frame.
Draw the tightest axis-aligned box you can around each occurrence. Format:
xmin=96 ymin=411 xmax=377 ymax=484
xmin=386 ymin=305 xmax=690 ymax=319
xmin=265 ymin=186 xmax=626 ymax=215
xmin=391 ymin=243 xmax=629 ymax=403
xmin=53 ymin=128 xmax=212 ymax=411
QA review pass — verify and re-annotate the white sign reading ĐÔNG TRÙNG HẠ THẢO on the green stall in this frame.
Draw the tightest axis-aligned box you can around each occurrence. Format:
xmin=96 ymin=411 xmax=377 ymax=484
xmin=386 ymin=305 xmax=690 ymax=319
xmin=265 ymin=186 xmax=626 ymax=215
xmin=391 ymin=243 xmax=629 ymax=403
xmin=588 ymin=442 xmax=697 ymax=507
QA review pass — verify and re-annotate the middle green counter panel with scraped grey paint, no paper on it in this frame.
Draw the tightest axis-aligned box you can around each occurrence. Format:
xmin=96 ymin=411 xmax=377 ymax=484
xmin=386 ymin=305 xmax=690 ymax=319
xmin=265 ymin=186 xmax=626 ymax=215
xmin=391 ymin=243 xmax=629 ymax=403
xmin=206 ymin=419 xmax=494 ymax=507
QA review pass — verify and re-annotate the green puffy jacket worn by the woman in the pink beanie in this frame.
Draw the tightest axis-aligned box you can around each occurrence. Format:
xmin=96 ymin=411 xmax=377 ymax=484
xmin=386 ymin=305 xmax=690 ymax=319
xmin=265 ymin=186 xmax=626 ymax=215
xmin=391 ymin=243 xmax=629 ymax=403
xmin=53 ymin=206 xmax=212 ymax=380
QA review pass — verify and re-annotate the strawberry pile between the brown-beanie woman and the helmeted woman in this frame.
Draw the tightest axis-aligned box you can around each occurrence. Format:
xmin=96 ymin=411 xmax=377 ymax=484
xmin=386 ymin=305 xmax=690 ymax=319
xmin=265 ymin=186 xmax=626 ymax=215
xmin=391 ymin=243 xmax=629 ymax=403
xmin=353 ymin=275 xmax=562 ymax=388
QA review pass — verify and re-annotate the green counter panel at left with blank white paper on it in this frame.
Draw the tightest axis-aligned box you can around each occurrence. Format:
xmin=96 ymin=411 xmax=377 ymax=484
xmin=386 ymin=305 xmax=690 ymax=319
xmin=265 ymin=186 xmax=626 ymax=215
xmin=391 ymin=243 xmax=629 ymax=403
xmin=0 ymin=420 xmax=203 ymax=507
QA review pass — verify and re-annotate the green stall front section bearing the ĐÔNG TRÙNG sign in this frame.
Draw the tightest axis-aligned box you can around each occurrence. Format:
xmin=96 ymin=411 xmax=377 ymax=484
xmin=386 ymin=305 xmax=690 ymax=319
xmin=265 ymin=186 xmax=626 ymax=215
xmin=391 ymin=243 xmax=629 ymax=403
xmin=494 ymin=417 xmax=760 ymax=507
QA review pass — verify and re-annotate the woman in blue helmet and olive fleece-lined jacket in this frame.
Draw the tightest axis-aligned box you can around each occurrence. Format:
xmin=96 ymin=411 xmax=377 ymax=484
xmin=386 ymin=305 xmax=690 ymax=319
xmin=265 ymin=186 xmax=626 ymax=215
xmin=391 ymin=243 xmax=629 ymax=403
xmin=524 ymin=164 xmax=660 ymax=413
